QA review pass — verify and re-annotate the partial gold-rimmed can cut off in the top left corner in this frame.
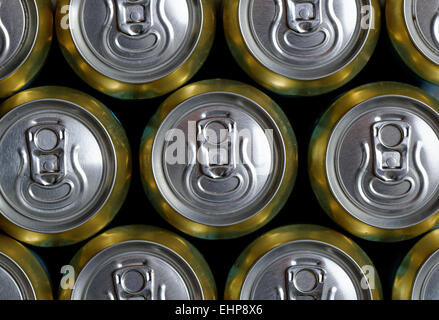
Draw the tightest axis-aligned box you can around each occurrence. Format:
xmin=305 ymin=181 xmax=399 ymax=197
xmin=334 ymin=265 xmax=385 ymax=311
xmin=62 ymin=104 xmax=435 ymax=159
xmin=0 ymin=0 xmax=53 ymax=99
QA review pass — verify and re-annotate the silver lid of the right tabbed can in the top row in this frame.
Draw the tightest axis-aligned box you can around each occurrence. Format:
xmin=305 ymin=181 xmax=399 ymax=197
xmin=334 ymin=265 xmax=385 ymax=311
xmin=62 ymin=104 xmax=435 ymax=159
xmin=239 ymin=0 xmax=372 ymax=80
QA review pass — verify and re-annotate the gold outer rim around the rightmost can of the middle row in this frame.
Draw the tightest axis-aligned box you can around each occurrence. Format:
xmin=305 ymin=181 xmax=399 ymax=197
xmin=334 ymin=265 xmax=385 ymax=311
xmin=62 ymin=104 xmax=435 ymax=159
xmin=308 ymin=82 xmax=439 ymax=242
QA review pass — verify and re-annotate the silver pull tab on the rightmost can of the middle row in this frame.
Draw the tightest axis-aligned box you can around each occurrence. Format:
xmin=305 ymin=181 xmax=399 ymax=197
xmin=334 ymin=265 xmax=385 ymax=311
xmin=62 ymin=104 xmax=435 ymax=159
xmin=372 ymin=120 xmax=411 ymax=181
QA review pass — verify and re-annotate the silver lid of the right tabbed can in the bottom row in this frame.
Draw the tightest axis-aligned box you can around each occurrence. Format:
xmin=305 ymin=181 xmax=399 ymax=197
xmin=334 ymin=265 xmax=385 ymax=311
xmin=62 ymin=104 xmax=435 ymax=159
xmin=240 ymin=240 xmax=372 ymax=300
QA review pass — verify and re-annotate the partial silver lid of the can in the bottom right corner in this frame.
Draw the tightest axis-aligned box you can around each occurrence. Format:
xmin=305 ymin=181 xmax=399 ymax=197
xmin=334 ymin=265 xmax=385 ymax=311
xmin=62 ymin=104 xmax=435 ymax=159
xmin=411 ymin=248 xmax=439 ymax=300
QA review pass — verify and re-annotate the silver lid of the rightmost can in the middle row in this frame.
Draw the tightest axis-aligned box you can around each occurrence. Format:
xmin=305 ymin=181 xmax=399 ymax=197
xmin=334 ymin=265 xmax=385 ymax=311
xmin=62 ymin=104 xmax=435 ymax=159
xmin=326 ymin=95 xmax=439 ymax=229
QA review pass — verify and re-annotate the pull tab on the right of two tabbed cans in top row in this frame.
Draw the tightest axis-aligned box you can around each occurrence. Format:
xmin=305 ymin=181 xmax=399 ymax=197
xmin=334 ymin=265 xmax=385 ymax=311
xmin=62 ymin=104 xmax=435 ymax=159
xmin=286 ymin=0 xmax=323 ymax=33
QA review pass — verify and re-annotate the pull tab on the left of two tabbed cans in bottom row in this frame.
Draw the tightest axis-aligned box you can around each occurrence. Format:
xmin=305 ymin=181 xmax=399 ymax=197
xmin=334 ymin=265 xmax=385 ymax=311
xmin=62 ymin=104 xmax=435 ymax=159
xmin=113 ymin=265 xmax=160 ymax=300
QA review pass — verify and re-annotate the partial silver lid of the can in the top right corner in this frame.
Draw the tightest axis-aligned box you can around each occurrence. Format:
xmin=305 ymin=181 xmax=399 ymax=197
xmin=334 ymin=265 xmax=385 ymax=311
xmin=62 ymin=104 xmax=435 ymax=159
xmin=404 ymin=0 xmax=439 ymax=65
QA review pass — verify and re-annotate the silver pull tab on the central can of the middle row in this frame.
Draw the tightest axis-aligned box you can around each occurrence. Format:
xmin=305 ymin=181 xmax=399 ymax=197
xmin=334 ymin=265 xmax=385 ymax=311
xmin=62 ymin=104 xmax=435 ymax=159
xmin=197 ymin=117 xmax=237 ymax=179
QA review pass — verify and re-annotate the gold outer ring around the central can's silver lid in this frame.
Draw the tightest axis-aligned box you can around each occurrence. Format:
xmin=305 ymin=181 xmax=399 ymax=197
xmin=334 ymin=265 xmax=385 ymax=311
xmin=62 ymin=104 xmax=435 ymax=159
xmin=140 ymin=79 xmax=298 ymax=239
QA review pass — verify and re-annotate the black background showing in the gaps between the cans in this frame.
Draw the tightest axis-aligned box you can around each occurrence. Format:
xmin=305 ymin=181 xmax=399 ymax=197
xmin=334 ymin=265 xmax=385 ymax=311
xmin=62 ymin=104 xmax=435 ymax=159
xmin=2 ymin=1 xmax=436 ymax=299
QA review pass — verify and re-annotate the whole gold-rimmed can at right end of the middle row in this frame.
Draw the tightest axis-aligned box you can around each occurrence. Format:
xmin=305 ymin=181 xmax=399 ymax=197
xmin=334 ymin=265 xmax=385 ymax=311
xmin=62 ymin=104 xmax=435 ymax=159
xmin=309 ymin=82 xmax=439 ymax=241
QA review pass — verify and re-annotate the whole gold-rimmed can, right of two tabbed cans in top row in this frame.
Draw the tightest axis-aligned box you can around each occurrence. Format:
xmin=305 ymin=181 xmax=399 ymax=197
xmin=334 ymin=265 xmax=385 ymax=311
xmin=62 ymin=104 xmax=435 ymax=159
xmin=223 ymin=0 xmax=381 ymax=96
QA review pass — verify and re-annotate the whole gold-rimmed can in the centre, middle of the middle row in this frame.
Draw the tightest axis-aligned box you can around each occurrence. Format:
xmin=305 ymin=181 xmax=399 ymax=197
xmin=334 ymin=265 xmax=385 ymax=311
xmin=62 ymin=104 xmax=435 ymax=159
xmin=140 ymin=79 xmax=297 ymax=239
